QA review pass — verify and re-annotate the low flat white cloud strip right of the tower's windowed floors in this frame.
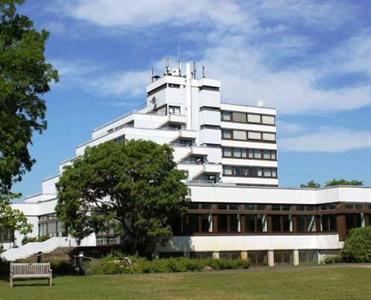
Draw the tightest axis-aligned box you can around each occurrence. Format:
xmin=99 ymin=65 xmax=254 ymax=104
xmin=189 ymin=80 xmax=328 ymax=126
xmin=279 ymin=128 xmax=371 ymax=152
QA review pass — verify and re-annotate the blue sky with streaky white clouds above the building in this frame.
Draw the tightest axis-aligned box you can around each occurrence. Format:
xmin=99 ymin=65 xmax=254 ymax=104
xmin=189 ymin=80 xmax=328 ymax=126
xmin=14 ymin=0 xmax=371 ymax=196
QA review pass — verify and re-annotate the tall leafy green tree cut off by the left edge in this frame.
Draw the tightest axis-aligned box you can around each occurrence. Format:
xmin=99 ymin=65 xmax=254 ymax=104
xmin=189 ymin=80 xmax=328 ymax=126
xmin=0 ymin=0 xmax=58 ymax=236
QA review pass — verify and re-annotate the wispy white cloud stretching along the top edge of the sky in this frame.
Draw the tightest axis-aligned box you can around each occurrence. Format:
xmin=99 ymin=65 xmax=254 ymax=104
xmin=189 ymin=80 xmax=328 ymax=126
xmin=64 ymin=0 xmax=253 ymax=29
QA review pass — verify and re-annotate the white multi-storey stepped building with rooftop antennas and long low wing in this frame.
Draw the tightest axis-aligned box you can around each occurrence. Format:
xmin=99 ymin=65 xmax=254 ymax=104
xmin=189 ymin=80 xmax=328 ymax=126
xmin=0 ymin=64 xmax=371 ymax=263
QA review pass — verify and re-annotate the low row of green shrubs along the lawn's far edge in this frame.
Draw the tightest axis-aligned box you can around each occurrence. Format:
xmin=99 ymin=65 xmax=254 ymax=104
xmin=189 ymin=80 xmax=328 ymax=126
xmin=86 ymin=256 xmax=249 ymax=274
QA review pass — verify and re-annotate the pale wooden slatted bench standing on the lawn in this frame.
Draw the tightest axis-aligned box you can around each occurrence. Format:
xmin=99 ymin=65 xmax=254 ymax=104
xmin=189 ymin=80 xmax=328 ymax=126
xmin=9 ymin=263 xmax=53 ymax=287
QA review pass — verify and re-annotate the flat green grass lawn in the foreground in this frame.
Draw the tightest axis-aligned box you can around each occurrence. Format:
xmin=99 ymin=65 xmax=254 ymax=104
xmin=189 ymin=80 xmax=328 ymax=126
xmin=0 ymin=266 xmax=371 ymax=300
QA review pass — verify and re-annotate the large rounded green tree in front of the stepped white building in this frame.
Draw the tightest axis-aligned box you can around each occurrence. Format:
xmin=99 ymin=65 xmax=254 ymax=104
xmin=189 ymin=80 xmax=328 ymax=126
xmin=56 ymin=140 xmax=188 ymax=255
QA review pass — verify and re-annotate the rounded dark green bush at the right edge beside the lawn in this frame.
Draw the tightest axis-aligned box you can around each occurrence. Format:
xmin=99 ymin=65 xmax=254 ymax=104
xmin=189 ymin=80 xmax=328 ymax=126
xmin=342 ymin=226 xmax=371 ymax=263
